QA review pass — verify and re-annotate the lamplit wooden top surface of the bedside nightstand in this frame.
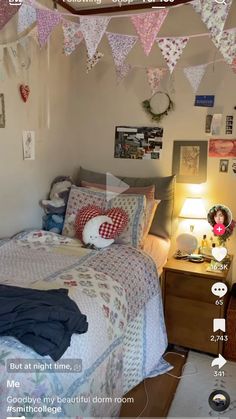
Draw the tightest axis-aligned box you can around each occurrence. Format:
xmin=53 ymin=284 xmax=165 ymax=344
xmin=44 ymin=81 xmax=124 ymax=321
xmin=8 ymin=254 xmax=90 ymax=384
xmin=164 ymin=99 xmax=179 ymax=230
xmin=163 ymin=257 xmax=233 ymax=280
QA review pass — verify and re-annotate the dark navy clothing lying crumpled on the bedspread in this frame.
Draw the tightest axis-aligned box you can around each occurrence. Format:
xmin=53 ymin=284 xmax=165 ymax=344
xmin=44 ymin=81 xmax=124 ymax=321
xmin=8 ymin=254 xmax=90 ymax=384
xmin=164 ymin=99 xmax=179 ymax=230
xmin=0 ymin=285 xmax=88 ymax=361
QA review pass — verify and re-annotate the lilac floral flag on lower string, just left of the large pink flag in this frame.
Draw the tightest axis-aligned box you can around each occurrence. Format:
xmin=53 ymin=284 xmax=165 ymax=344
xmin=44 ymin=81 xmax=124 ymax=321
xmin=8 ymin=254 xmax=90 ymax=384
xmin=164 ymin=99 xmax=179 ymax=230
xmin=107 ymin=32 xmax=138 ymax=67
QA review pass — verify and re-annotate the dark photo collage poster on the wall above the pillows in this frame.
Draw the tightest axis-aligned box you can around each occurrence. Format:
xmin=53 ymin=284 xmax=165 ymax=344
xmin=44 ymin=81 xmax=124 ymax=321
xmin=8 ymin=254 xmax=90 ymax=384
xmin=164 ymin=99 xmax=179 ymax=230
xmin=114 ymin=126 xmax=163 ymax=160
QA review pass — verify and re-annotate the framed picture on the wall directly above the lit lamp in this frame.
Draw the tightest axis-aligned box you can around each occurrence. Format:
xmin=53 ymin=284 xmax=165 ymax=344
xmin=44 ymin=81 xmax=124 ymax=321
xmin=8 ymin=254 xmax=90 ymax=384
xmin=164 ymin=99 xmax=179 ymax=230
xmin=172 ymin=141 xmax=208 ymax=183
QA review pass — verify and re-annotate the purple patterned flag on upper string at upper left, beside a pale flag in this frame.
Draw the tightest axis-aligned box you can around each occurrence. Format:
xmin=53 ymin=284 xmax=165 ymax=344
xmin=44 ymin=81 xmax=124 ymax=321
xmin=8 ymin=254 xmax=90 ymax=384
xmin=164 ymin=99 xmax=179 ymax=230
xmin=36 ymin=9 xmax=61 ymax=47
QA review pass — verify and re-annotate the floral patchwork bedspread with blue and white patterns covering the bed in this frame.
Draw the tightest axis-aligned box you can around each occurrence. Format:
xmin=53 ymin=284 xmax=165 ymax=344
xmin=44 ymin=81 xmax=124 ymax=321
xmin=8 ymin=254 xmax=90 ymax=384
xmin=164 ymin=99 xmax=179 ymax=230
xmin=0 ymin=231 xmax=171 ymax=419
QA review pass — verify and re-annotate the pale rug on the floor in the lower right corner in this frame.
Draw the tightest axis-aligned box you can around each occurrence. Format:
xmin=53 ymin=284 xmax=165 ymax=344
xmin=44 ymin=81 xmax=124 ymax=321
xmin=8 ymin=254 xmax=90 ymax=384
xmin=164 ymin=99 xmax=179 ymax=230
xmin=167 ymin=351 xmax=236 ymax=419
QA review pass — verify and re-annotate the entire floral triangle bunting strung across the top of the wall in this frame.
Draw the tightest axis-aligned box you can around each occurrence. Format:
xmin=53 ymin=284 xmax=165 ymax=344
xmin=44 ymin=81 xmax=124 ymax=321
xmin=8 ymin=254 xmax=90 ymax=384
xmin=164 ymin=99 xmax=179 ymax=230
xmin=0 ymin=0 xmax=236 ymax=87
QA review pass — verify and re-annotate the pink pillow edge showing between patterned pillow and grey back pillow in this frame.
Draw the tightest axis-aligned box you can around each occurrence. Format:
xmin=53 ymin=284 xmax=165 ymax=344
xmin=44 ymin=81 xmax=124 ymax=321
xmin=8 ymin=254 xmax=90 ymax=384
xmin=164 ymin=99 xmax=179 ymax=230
xmin=81 ymin=180 xmax=155 ymax=200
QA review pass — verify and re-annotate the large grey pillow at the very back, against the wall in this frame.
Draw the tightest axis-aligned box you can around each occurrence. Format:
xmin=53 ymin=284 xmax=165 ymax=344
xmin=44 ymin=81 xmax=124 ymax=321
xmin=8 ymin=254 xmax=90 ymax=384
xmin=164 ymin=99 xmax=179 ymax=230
xmin=76 ymin=167 xmax=176 ymax=238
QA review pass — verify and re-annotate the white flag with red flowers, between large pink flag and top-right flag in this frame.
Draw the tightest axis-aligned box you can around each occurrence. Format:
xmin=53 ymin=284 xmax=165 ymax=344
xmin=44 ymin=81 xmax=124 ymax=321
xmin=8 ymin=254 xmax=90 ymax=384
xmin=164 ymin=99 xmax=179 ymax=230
xmin=157 ymin=37 xmax=189 ymax=73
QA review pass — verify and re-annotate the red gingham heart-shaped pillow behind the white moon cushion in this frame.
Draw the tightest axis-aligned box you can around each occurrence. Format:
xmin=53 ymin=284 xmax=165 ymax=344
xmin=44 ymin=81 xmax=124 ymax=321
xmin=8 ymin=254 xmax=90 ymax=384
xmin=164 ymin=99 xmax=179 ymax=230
xmin=75 ymin=205 xmax=128 ymax=241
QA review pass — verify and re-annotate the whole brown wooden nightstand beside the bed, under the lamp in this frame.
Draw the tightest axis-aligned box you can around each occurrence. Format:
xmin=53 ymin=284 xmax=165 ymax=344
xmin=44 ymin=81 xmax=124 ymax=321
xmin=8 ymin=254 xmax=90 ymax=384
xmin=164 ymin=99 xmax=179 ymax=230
xmin=162 ymin=258 xmax=230 ymax=354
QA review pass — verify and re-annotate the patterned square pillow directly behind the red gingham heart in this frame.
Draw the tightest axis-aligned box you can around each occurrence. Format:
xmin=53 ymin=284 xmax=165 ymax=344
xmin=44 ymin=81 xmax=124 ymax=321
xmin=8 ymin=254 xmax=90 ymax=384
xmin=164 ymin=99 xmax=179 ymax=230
xmin=62 ymin=186 xmax=146 ymax=247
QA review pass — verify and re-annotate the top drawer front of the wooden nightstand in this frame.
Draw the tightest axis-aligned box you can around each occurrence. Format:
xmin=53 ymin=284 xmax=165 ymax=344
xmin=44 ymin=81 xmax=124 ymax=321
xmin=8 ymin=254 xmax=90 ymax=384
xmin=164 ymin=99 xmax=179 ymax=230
xmin=165 ymin=271 xmax=216 ymax=304
